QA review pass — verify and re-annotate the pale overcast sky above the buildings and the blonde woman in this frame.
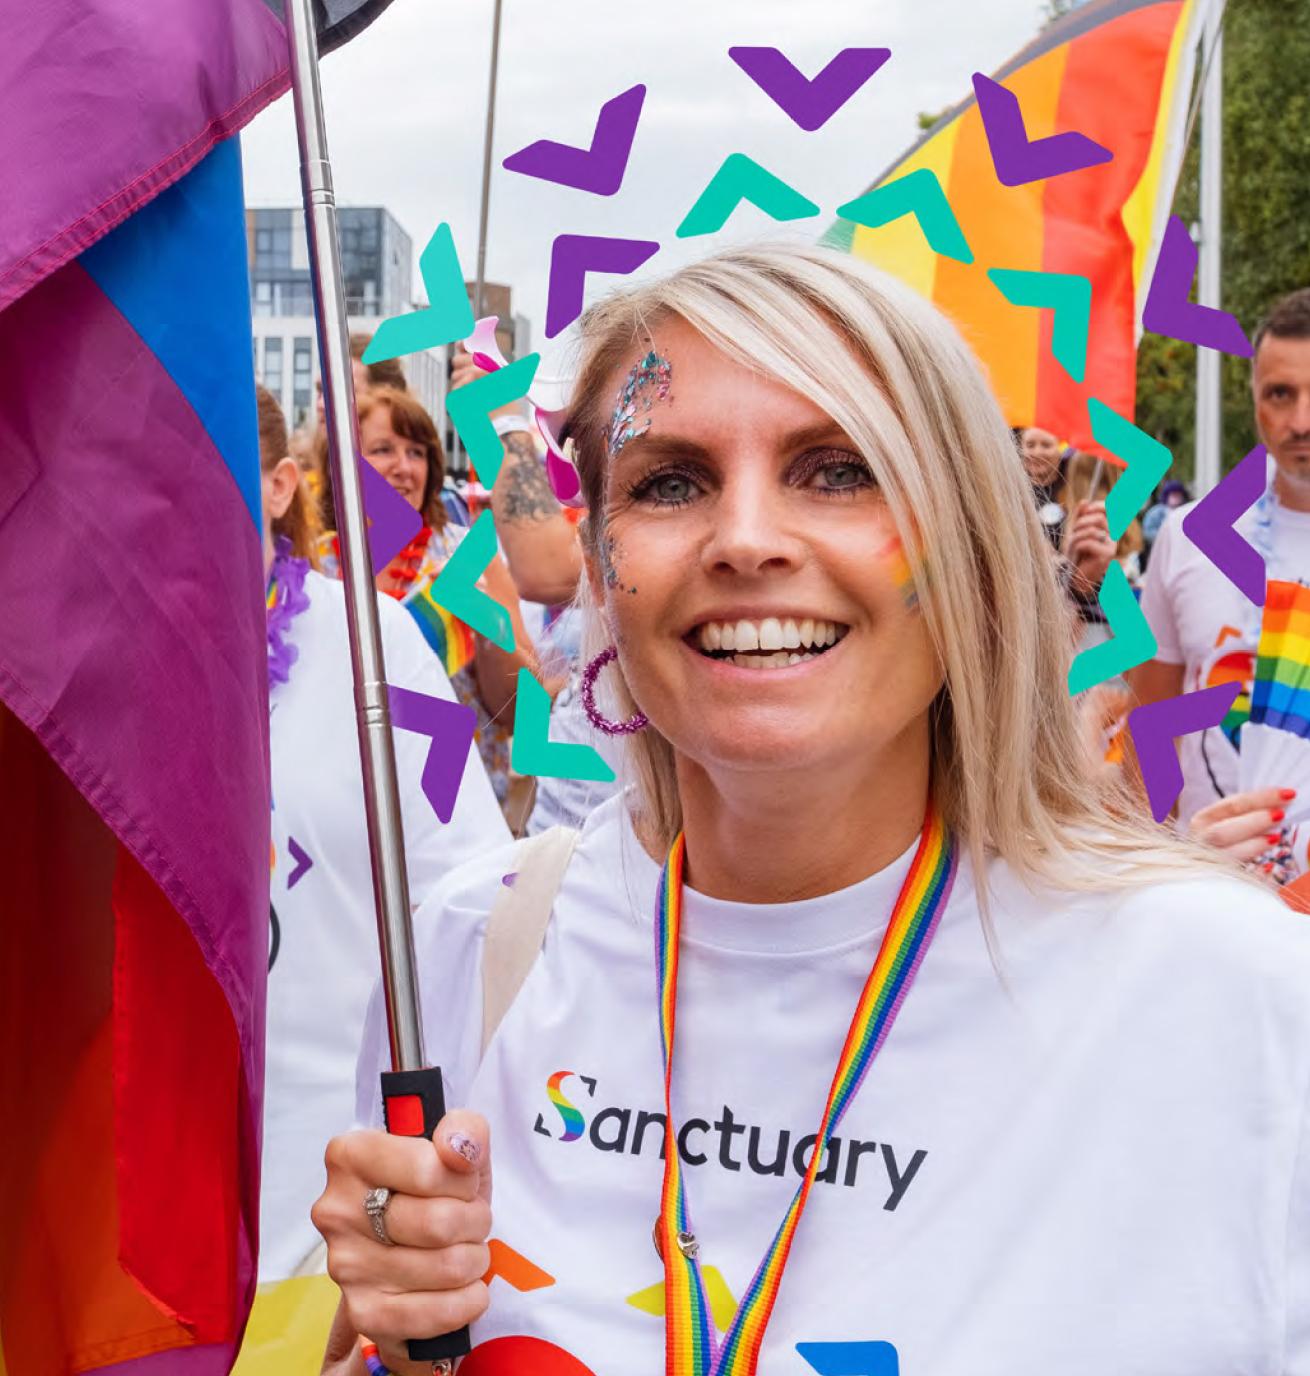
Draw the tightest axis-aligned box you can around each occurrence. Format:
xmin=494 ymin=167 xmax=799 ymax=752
xmin=242 ymin=0 xmax=1042 ymax=373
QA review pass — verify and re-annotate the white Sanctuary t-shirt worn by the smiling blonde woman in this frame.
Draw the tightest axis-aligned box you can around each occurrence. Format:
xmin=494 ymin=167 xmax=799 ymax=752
xmin=359 ymin=795 xmax=1310 ymax=1376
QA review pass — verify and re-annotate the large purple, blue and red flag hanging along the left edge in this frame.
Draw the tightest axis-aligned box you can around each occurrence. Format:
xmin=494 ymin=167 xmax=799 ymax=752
xmin=0 ymin=0 xmax=384 ymax=1376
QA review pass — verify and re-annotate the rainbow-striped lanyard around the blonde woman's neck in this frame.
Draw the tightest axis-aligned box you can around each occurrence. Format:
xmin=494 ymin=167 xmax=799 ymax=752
xmin=655 ymin=806 xmax=958 ymax=1376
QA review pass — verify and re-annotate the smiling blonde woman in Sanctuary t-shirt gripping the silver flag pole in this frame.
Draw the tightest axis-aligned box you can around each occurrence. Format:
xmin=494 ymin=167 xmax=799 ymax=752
xmin=304 ymin=248 xmax=1310 ymax=1376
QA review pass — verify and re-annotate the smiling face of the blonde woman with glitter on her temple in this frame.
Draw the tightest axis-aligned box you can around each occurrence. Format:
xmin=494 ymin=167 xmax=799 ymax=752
xmin=589 ymin=321 xmax=943 ymax=773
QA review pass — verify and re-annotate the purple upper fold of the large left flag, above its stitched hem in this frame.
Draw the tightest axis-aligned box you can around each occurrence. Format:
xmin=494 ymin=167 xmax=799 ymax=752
xmin=0 ymin=0 xmax=389 ymax=310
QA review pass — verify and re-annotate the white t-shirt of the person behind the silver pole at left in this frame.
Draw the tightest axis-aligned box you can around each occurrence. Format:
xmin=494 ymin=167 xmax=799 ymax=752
xmin=260 ymin=571 xmax=509 ymax=1281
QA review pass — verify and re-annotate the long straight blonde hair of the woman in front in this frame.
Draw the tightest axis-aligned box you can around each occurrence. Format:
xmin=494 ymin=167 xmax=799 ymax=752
xmin=568 ymin=245 xmax=1236 ymax=889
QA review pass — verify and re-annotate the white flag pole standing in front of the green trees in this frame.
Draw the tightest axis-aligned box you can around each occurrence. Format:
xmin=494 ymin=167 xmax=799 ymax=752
xmin=1193 ymin=4 xmax=1223 ymax=497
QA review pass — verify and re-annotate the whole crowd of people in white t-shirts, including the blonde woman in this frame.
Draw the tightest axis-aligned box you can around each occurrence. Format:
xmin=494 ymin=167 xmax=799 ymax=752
xmin=250 ymin=248 xmax=1310 ymax=1376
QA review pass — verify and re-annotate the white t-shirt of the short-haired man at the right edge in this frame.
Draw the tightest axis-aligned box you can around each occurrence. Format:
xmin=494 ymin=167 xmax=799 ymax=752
xmin=1142 ymin=504 xmax=1310 ymax=827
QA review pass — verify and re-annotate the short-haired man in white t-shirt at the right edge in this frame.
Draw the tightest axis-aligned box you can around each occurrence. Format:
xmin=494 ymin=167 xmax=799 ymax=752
xmin=1131 ymin=289 xmax=1310 ymax=860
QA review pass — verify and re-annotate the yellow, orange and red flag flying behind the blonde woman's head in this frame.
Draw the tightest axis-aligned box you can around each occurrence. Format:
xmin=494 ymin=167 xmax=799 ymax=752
xmin=824 ymin=0 xmax=1207 ymax=450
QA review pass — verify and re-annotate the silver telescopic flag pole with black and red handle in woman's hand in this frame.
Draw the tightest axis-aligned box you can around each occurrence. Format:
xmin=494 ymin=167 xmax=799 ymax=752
xmin=285 ymin=0 xmax=469 ymax=1372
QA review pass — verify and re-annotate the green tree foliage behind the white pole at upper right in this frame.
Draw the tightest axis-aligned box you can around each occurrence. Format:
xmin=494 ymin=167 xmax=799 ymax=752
xmin=1137 ymin=0 xmax=1310 ymax=477
